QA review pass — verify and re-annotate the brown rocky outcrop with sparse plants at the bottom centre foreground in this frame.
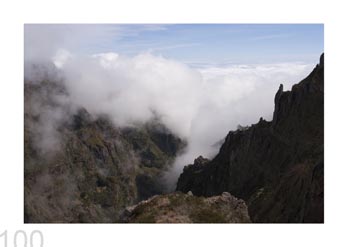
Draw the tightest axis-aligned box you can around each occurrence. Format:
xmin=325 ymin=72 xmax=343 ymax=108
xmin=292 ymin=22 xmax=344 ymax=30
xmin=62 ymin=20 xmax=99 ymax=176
xmin=121 ymin=192 xmax=251 ymax=223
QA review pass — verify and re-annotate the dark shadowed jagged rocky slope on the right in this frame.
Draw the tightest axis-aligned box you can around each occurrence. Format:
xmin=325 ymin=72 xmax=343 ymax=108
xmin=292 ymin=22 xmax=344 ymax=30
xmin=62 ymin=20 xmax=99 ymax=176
xmin=177 ymin=55 xmax=324 ymax=222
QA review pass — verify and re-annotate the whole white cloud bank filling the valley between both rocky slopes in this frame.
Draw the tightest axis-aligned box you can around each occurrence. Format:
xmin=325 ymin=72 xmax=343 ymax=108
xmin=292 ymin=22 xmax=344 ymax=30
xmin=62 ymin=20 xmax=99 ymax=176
xmin=25 ymin=24 xmax=313 ymax=187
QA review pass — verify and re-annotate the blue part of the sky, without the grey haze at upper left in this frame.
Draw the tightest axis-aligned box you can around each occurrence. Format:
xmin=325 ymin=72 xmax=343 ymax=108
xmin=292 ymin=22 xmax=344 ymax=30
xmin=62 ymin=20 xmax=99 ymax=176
xmin=75 ymin=24 xmax=324 ymax=63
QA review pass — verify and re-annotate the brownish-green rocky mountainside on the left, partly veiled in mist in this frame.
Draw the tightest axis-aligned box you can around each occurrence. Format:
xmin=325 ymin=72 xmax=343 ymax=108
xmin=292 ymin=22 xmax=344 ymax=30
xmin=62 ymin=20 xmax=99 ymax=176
xmin=24 ymin=67 xmax=185 ymax=223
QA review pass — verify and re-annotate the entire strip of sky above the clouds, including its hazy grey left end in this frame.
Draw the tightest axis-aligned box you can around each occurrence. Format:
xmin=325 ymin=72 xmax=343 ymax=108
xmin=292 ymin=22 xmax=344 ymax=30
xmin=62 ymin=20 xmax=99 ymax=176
xmin=24 ymin=24 xmax=324 ymax=64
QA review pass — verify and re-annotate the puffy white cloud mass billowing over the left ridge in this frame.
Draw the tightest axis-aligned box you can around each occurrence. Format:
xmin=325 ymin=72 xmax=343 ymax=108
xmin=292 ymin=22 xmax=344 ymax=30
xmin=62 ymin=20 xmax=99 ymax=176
xmin=62 ymin=53 xmax=203 ymax=138
